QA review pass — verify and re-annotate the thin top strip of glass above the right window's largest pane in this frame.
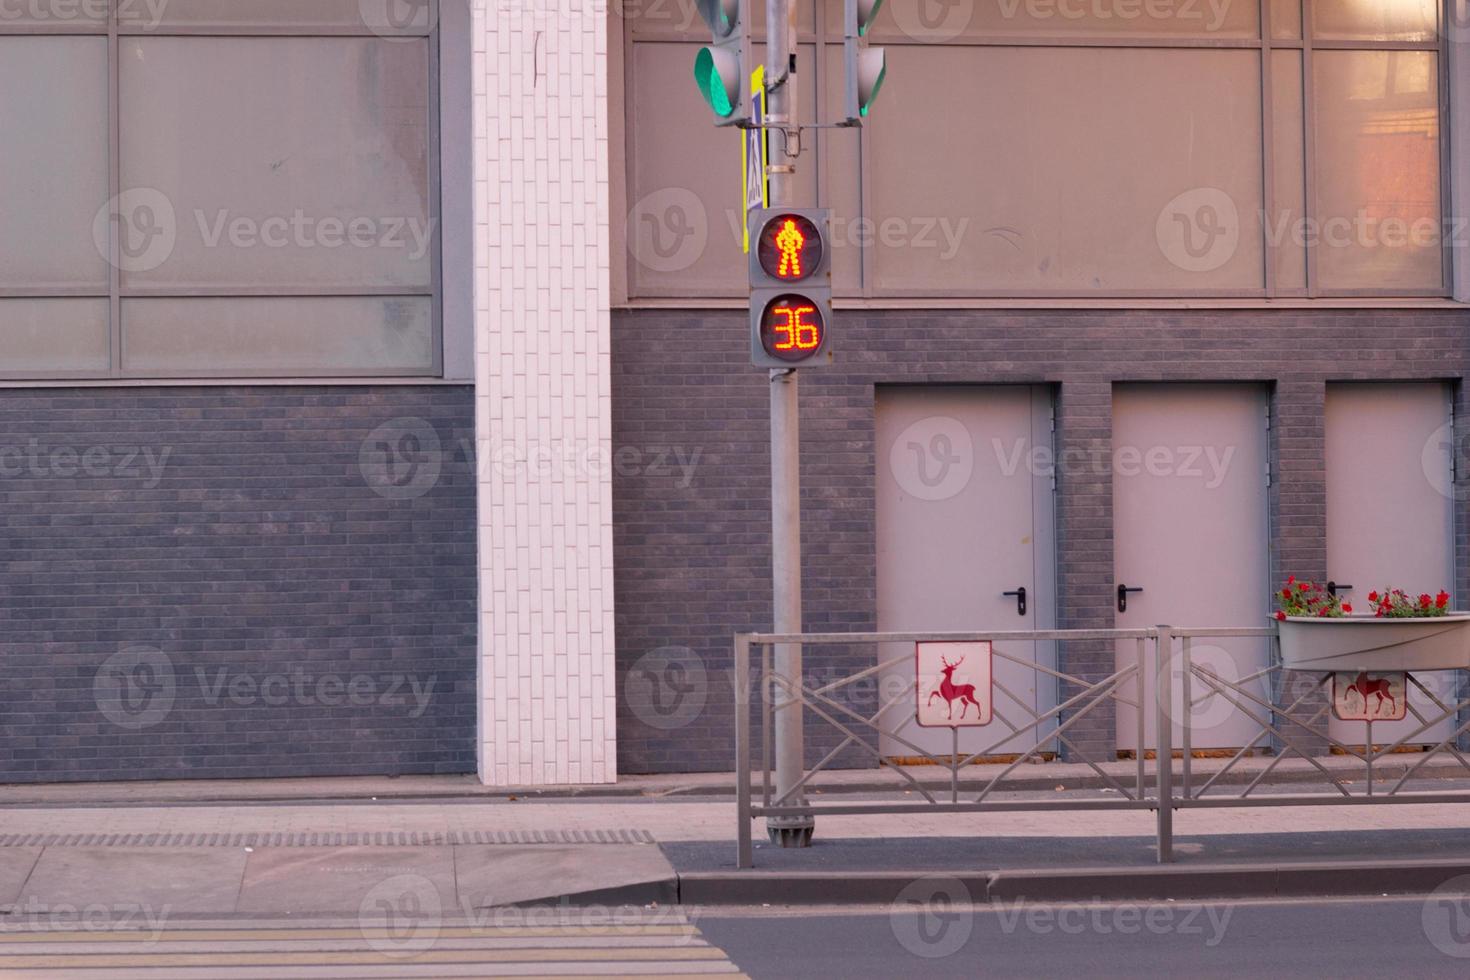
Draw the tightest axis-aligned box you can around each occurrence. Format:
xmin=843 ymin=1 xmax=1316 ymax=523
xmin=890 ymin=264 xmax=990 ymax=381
xmin=864 ymin=0 xmax=1260 ymax=44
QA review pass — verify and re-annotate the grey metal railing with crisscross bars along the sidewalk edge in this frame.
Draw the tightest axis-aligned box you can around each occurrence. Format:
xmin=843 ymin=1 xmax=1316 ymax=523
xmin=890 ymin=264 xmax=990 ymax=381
xmin=735 ymin=626 xmax=1470 ymax=868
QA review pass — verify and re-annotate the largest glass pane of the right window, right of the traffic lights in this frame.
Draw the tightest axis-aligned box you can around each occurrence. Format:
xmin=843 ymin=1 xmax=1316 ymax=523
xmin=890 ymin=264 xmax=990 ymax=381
xmin=864 ymin=46 xmax=1264 ymax=295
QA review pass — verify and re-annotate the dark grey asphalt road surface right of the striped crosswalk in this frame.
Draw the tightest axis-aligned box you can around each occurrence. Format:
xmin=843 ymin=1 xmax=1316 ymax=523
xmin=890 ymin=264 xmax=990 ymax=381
xmin=691 ymin=898 xmax=1470 ymax=980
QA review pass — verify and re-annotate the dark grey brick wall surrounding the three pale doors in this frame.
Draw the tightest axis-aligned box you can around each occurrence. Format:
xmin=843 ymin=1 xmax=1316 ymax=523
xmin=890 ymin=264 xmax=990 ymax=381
xmin=613 ymin=309 xmax=1470 ymax=773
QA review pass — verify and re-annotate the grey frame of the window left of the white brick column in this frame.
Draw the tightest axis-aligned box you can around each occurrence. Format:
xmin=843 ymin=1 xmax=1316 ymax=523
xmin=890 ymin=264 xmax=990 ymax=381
xmin=0 ymin=0 xmax=446 ymax=383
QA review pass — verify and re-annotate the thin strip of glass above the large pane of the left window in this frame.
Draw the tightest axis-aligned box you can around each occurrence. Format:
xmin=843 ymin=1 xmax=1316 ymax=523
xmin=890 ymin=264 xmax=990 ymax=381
xmin=139 ymin=0 xmax=438 ymax=37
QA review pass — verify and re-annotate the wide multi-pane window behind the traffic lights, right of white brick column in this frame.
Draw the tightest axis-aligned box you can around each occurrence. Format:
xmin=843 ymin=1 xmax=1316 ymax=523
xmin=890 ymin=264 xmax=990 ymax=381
xmin=623 ymin=0 xmax=1457 ymax=301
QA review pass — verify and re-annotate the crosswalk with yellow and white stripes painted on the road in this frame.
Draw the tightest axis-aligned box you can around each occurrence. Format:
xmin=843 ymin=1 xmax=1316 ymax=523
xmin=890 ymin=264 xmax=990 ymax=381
xmin=0 ymin=908 xmax=744 ymax=980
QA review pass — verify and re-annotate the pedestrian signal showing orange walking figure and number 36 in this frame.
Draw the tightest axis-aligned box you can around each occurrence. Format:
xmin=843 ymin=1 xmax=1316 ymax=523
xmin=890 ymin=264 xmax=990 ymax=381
xmin=750 ymin=207 xmax=832 ymax=367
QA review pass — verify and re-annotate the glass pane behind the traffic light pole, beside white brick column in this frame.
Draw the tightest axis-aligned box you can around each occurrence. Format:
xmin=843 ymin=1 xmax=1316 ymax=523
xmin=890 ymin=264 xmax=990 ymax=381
xmin=623 ymin=41 xmax=817 ymax=297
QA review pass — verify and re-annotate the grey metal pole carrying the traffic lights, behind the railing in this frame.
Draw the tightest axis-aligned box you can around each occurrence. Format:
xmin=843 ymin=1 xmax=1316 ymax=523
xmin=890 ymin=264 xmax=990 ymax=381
xmin=766 ymin=0 xmax=816 ymax=848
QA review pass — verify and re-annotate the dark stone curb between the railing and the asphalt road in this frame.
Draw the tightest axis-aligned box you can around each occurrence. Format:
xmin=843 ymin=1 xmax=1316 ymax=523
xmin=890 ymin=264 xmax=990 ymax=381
xmin=526 ymin=857 xmax=1470 ymax=908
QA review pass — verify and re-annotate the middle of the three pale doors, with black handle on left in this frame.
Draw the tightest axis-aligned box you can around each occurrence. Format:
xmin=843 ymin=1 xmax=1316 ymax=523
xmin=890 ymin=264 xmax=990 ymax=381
xmin=1110 ymin=385 xmax=1270 ymax=749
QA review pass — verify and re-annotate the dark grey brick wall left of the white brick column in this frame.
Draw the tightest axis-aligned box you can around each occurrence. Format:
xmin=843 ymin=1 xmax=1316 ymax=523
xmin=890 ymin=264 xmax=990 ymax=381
xmin=0 ymin=386 xmax=476 ymax=782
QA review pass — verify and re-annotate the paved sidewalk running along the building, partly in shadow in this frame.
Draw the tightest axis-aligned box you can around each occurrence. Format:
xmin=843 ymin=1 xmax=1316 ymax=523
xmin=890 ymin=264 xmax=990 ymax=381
xmin=0 ymin=789 xmax=1470 ymax=923
